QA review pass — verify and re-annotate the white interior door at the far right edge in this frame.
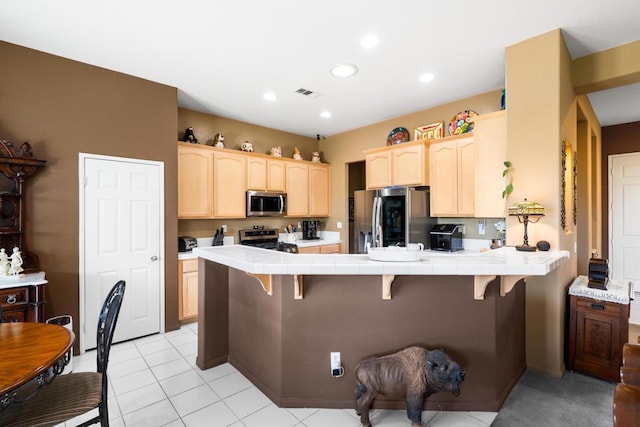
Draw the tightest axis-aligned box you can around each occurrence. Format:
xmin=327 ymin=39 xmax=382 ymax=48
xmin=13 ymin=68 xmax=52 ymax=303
xmin=609 ymin=153 xmax=640 ymax=324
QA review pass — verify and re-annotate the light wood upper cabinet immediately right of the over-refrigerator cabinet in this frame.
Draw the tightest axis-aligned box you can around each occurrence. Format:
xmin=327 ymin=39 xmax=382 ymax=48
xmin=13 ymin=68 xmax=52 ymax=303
xmin=429 ymin=135 xmax=475 ymax=217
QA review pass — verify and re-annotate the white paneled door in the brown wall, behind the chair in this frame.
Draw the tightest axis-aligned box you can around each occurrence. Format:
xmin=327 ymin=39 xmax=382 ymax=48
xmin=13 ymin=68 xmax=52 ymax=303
xmin=80 ymin=155 xmax=164 ymax=351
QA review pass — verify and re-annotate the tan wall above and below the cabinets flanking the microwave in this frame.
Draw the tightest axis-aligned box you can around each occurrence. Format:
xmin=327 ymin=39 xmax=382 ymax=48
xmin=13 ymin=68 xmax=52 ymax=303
xmin=176 ymin=108 xmax=318 ymax=242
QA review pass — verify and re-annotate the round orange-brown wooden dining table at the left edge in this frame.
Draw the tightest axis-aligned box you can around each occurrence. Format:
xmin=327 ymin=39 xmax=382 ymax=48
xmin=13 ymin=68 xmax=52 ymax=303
xmin=0 ymin=322 xmax=75 ymax=406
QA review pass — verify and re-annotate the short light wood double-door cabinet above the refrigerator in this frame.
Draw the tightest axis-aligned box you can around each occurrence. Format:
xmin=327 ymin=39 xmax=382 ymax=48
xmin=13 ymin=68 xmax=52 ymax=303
xmin=364 ymin=139 xmax=429 ymax=189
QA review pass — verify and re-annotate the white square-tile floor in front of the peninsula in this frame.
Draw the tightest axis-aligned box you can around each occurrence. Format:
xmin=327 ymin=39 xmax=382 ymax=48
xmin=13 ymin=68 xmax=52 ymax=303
xmin=57 ymin=323 xmax=497 ymax=427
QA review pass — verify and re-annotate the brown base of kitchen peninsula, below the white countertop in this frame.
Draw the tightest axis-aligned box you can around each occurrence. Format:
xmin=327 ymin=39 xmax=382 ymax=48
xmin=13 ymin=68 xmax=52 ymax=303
xmin=196 ymin=258 xmax=526 ymax=411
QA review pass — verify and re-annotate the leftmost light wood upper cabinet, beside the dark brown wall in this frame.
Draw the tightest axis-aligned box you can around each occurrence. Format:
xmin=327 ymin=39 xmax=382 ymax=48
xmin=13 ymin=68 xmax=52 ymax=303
xmin=178 ymin=143 xmax=213 ymax=218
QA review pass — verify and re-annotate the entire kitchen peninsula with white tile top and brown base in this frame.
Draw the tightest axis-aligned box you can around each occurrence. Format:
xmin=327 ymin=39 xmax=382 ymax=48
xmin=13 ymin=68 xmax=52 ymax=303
xmin=194 ymin=245 xmax=569 ymax=411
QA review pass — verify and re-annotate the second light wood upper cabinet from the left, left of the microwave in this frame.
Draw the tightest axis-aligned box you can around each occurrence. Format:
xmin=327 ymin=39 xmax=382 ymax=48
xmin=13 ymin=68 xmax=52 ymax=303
xmin=213 ymin=150 xmax=247 ymax=218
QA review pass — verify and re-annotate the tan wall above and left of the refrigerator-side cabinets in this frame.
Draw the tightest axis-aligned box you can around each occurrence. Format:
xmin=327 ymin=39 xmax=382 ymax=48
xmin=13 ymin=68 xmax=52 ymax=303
xmin=320 ymin=89 xmax=502 ymax=241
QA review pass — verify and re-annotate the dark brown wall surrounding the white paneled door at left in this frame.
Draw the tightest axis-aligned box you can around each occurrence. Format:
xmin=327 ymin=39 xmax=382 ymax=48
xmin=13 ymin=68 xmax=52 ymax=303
xmin=0 ymin=42 xmax=178 ymax=348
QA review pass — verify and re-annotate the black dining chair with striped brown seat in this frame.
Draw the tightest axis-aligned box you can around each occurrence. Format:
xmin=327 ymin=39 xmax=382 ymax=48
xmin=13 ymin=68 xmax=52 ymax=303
xmin=0 ymin=280 xmax=125 ymax=427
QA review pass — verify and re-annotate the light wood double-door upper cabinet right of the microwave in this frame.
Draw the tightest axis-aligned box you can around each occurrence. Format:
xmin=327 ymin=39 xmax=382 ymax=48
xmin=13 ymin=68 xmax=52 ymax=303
xmin=286 ymin=162 xmax=331 ymax=217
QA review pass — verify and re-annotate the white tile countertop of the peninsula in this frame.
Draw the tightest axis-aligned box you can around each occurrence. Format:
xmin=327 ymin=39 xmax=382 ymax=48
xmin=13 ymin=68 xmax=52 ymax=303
xmin=193 ymin=245 xmax=569 ymax=276
